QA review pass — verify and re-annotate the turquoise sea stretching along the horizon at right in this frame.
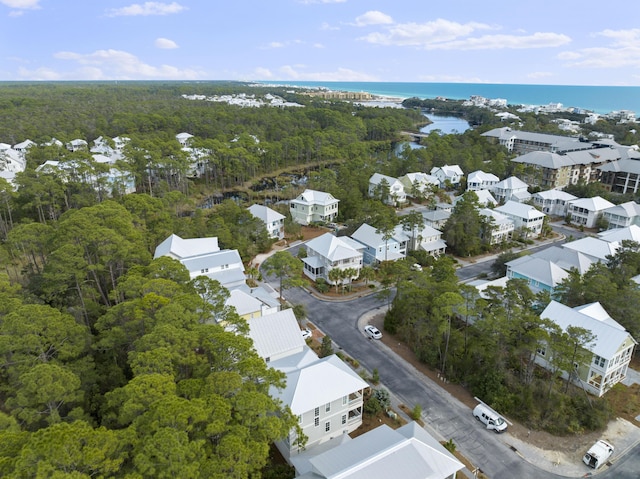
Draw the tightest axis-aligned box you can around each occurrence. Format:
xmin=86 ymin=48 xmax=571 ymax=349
xmin=260 ymin=81 xmax=640 ymax=115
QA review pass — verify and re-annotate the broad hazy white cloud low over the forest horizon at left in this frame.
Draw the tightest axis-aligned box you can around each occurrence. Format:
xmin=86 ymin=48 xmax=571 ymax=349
xmin=54 ymin=50 xmax=204 ymax=80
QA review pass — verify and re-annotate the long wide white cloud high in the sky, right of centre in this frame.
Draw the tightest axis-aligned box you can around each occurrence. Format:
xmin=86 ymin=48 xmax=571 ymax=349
xmin=361 ymin=18 xmax=571 ymax=50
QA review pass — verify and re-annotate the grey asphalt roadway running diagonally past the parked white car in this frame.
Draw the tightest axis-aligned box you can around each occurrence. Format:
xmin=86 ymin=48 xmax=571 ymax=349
xmin=278 ymin=288 xmax=562 ymax=479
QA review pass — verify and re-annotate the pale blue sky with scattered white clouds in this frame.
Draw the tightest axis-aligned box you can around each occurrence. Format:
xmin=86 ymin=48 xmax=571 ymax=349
xmin=0 ymin=0 xmax=640 ymax=86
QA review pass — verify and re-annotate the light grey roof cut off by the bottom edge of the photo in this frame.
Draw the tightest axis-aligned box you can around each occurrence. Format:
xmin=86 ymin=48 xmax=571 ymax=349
xmin=302 ymin=422 xmax=464 ymax=479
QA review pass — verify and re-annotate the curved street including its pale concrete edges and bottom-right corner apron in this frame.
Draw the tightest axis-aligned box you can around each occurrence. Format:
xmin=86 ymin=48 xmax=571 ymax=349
xmin=258 ymin=246 xmax=640 ymax=479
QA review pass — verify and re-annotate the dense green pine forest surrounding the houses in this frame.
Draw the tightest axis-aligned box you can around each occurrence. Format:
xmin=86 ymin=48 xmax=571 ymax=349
xmin=0 ymin=82 xmax=640 ymax=479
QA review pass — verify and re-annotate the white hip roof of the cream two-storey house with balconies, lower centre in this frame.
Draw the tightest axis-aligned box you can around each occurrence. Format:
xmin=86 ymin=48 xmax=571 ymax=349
xmin=272 ymin=356 xmax=369 ymax=415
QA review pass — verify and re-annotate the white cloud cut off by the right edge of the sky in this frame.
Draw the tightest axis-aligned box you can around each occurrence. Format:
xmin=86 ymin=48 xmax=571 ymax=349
xmin=558 ymin=28 xmax=640 ymax=69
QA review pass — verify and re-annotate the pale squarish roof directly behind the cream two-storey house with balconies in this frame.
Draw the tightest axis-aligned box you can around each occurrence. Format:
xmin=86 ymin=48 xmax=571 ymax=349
xmin=248 ymin=309 xmax=306 ymax=359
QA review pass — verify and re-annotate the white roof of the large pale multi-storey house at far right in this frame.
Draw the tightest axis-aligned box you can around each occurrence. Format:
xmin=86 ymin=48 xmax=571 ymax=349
xmin=540 ymin=301 xmax=635 ymax=359
